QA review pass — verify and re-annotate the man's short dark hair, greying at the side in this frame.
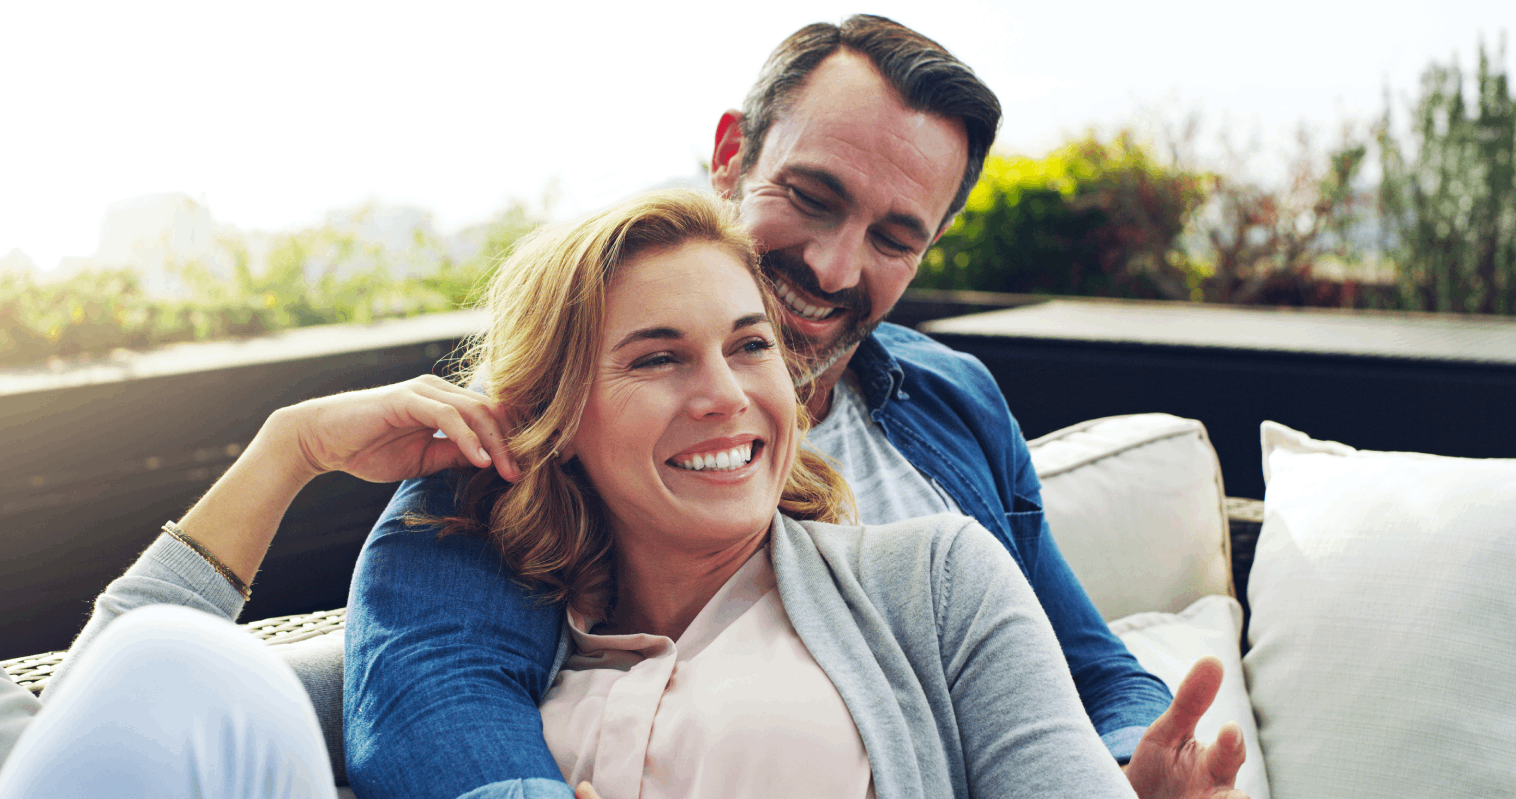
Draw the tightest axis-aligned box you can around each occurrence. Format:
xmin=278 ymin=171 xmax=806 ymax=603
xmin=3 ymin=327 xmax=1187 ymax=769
xmin=741 ymin=14 xmax=1001 ymax=231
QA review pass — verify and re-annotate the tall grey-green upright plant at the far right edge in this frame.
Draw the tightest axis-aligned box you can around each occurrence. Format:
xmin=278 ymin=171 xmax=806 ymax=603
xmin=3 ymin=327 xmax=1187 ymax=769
xmin=1378 ymin=36 xmax=1516 ymax=314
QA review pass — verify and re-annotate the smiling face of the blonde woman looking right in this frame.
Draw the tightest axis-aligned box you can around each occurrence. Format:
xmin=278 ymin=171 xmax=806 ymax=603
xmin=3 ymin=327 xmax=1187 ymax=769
xmin=569 ymin=243 xmax=797 ymax=550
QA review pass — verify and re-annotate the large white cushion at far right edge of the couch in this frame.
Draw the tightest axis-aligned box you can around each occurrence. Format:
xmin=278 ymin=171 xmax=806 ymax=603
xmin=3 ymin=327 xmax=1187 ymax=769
xmin=1243 ymin=421 xmax=1516 ymax=799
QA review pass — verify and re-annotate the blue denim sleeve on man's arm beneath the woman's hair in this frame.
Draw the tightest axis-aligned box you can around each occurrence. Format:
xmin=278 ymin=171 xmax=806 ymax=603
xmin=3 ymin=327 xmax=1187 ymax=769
xmin=343 ymin=473 xmax=572 ymax=799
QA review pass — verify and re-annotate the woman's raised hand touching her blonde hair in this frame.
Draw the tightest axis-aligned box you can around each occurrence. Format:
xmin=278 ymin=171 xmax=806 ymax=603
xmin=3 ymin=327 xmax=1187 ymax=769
xmin=270 ymin=374 xmax=520 ymax=482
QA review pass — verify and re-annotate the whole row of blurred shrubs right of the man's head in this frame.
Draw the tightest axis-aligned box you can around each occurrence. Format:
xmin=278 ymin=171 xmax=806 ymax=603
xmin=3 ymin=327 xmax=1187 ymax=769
xmin=914 ymin=37 xmax=1516 ymax=314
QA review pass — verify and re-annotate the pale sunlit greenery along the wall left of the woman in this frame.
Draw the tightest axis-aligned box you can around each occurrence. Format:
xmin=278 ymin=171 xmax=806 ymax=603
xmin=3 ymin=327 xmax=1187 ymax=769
xmin=0 ymin=206 xmax=535 ymax=365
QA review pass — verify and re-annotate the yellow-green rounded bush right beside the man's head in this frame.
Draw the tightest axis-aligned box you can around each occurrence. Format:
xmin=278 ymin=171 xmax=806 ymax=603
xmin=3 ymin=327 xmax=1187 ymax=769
xmin=914 ymin=133 xmax=1204 ymax=297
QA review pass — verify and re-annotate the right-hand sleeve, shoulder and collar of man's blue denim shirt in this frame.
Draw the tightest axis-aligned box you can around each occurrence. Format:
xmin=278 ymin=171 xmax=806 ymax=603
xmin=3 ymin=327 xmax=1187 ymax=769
xmin=849 ymin=324 xmax=1172 ymax=763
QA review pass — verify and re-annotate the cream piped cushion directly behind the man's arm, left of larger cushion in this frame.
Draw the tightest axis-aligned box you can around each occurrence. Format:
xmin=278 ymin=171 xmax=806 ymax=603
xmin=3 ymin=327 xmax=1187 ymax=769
xmin=1029 ymin=414 xmax=1233 ymax=620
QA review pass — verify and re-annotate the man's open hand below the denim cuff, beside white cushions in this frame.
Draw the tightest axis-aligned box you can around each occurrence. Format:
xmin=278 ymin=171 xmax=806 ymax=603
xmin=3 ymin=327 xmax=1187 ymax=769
xmin=1125 ymin=658 xmax=1248 ymax=799
